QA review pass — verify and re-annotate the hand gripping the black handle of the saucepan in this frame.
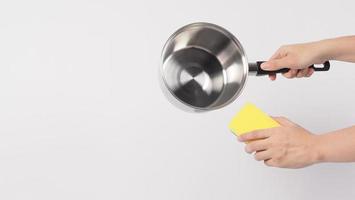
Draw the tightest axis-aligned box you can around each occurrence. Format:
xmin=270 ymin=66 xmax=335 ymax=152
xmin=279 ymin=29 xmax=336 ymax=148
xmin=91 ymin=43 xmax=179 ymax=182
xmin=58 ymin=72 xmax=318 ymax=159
xmin=261 ymin=42 xmax=326 ymax=80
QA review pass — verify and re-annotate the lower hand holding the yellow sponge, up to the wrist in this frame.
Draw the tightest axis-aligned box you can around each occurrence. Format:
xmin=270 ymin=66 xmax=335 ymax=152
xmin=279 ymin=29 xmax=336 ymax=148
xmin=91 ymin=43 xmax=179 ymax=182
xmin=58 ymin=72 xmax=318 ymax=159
xmin=238 ymin=117 xmax=318 ymax=168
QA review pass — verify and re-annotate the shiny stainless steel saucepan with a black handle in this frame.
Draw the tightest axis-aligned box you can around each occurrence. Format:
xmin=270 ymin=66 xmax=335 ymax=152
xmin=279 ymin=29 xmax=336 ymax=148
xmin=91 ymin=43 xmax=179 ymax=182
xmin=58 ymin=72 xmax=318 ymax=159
xmin=160 ymin=23 xmax=330 ymax=112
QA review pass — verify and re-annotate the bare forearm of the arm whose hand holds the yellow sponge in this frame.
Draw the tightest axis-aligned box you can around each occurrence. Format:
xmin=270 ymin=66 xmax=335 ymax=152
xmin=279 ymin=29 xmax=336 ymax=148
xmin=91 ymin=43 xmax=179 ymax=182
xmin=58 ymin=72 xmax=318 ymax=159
xmin=314 ymin=126 xmax=355 ymax=162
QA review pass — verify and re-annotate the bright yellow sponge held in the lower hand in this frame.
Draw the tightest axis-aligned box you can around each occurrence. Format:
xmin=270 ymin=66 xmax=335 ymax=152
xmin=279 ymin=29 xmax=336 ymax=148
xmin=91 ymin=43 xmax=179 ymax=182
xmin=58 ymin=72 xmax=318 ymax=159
xmin=228 ymin=103 xmax=280 ymax=136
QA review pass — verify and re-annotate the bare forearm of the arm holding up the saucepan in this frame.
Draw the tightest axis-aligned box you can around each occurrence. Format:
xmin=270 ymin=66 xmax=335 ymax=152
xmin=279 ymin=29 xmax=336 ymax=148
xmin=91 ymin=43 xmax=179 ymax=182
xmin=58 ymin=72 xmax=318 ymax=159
xmin=316 ymin=36 xmax=355 ymax=62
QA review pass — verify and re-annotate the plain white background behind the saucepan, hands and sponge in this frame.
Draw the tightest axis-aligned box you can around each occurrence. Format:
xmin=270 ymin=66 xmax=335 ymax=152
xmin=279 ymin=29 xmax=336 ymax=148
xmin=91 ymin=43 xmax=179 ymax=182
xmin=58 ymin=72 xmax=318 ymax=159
xmin=0 ymin=0 xmax=355 ymax=200
